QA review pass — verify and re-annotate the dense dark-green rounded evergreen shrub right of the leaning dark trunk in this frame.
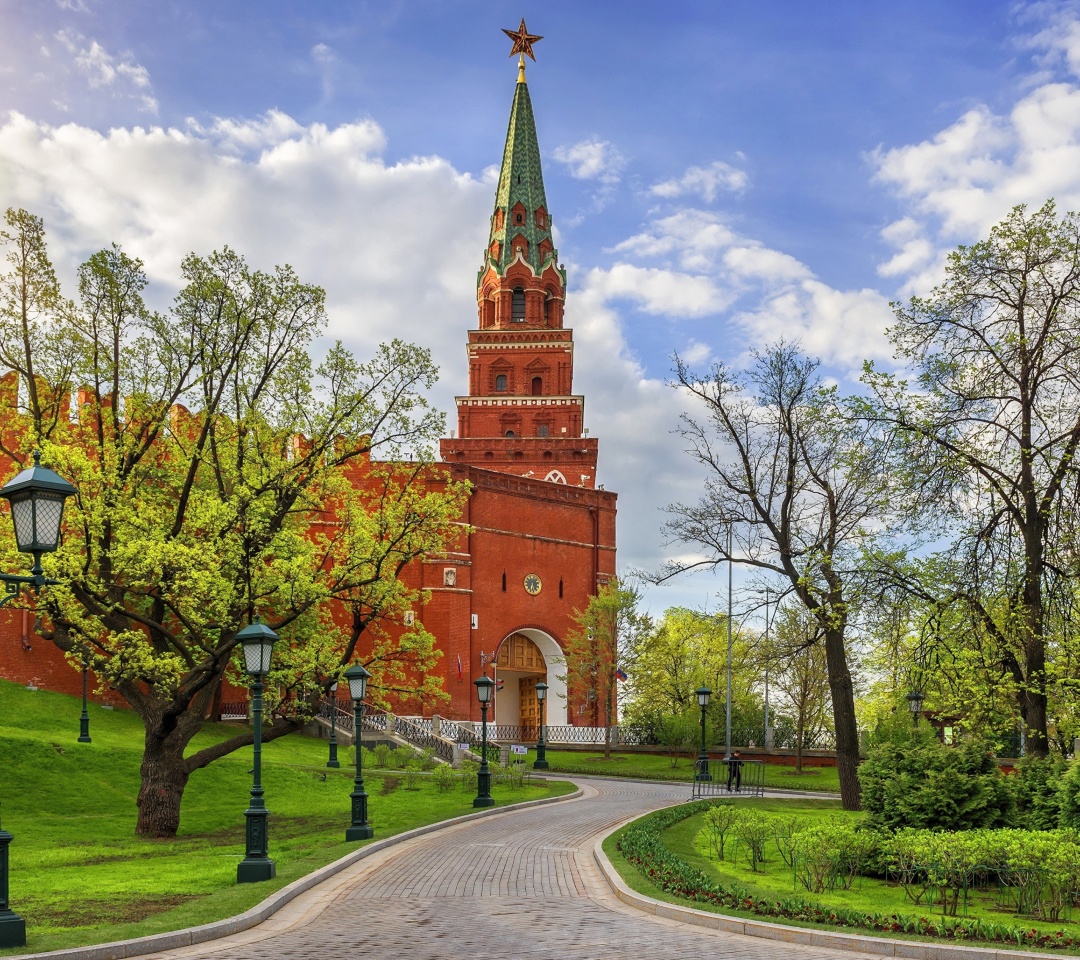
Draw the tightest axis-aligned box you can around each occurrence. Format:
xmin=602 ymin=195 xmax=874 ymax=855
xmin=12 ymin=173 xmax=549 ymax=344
xmin=859 ymin=726 xmax=1013 ymax=830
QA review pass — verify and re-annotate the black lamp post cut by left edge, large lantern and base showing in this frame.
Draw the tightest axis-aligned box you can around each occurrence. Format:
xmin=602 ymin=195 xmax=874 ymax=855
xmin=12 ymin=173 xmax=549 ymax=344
xmin=0 ymin=451 xmax=76 ymax=947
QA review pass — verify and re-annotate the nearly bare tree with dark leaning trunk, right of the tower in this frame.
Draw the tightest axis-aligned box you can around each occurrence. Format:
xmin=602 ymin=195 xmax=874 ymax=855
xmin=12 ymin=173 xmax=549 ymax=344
xmin=667 ymin=343 xmax=888 ymax=810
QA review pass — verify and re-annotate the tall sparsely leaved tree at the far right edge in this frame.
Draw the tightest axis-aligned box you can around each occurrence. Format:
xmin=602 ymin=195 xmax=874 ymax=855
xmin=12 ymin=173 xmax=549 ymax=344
xmin=862 ymin=201 xmax=1080 ymax=756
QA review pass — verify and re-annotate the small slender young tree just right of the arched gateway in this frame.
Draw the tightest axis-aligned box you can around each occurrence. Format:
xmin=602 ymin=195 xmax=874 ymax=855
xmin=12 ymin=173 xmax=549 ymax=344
xmin=564 ymin=580 xmax=652 ymax=759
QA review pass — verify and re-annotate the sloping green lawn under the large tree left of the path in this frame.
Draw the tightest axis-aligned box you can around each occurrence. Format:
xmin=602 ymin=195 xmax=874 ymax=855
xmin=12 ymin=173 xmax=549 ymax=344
xmin=0 ymin=681 xmax=573 ymax=956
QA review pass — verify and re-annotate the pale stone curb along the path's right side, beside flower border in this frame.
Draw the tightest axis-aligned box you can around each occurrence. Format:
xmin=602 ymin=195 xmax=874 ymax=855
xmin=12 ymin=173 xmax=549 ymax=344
xmin=593 ymin=833 xmax=1062 ymax=960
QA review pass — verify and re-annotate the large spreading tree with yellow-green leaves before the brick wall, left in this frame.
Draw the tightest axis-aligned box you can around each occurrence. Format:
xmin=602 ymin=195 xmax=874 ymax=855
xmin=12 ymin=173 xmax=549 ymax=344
xmin=0 ymin=212 xmax=464 ymax=837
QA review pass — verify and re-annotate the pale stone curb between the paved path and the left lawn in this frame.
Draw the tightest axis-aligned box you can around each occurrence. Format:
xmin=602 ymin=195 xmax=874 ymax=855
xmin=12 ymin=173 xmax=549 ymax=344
xmin=5 ymin=787 xmax=583 ymax=960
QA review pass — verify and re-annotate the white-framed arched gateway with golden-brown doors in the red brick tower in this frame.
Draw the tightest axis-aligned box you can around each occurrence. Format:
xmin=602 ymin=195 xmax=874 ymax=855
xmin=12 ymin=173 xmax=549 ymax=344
xmin=495 ymin=627 xmax=566 ymax=730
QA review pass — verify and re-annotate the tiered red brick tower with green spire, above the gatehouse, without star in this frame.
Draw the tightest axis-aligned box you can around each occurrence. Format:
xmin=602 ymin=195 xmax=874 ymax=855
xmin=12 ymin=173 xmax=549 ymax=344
xmin=442 ymin=56 xmax=597 ymax=488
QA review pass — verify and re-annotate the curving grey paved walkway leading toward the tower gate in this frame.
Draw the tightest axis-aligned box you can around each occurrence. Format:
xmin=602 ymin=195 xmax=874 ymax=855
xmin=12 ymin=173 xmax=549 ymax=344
xmin=126 ymin=780 xmax=881 ymax=960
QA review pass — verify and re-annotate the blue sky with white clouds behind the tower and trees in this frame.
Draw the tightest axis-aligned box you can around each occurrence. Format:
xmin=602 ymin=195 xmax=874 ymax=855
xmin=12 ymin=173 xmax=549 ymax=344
xmin=0 ymin=0 xmax=1080 ymax=610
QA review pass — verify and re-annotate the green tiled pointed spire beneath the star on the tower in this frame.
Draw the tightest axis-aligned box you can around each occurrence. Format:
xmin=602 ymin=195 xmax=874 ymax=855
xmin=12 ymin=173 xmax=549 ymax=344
xmin=487 ymin=71 xmax=555 ymax=274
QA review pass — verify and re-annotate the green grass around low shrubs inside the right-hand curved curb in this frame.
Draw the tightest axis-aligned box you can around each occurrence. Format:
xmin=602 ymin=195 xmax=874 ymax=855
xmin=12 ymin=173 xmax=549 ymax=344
xmin=604 ymin=799 xmax=1080 ymax=952
